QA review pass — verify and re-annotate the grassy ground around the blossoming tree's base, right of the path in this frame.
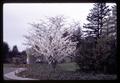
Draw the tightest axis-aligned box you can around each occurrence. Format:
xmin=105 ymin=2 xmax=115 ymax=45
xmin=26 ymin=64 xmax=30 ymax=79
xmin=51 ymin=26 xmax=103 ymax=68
xmin=17 ymin=63 xmax=117 ymax=80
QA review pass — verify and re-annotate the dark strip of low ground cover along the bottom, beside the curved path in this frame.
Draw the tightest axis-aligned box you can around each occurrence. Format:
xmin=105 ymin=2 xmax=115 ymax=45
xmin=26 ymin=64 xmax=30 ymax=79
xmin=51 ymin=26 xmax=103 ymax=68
xmin=18 ymin=68 xmax=117 ymax=80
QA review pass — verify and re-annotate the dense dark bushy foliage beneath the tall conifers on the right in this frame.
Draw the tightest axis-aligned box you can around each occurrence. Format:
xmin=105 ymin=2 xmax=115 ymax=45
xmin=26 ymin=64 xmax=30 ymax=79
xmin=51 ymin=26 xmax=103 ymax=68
xmin=76 ymin=35 xmax=117 ymax=74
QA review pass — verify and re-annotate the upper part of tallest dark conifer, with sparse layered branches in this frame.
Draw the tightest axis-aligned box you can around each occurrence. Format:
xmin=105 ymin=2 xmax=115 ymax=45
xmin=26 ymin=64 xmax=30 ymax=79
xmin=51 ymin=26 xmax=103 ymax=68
xmin=83 ymin=3 xmax=110 ymax=38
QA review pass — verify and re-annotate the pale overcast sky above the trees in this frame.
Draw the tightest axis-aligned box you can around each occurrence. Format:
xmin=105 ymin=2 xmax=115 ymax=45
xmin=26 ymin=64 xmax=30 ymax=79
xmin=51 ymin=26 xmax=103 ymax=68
xmin=3 ymin=3 xmax=114 ymax=51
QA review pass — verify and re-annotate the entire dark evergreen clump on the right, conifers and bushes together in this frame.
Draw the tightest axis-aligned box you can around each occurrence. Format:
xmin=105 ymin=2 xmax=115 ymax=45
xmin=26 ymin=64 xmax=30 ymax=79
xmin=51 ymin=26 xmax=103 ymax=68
xmin=76 ymin=3 xmax=117 ymax=74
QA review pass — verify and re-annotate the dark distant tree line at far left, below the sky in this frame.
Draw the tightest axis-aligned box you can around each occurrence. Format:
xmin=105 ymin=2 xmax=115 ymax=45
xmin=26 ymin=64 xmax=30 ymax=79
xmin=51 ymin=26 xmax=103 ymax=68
xmin=3 ymin=42 xmax=26 ymax=63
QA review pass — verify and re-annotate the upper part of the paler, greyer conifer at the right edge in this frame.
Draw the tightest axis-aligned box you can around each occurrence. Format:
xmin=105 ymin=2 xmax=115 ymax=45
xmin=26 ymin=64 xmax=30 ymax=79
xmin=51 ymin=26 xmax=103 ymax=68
xmin=103 ymin=5 xmax=117 ymax=39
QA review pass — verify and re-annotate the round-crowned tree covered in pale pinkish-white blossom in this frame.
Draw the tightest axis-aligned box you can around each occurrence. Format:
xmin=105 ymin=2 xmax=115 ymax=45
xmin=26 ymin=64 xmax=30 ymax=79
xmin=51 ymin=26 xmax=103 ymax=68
xmin=25 ymin=16 xmax=77 ymax=68
